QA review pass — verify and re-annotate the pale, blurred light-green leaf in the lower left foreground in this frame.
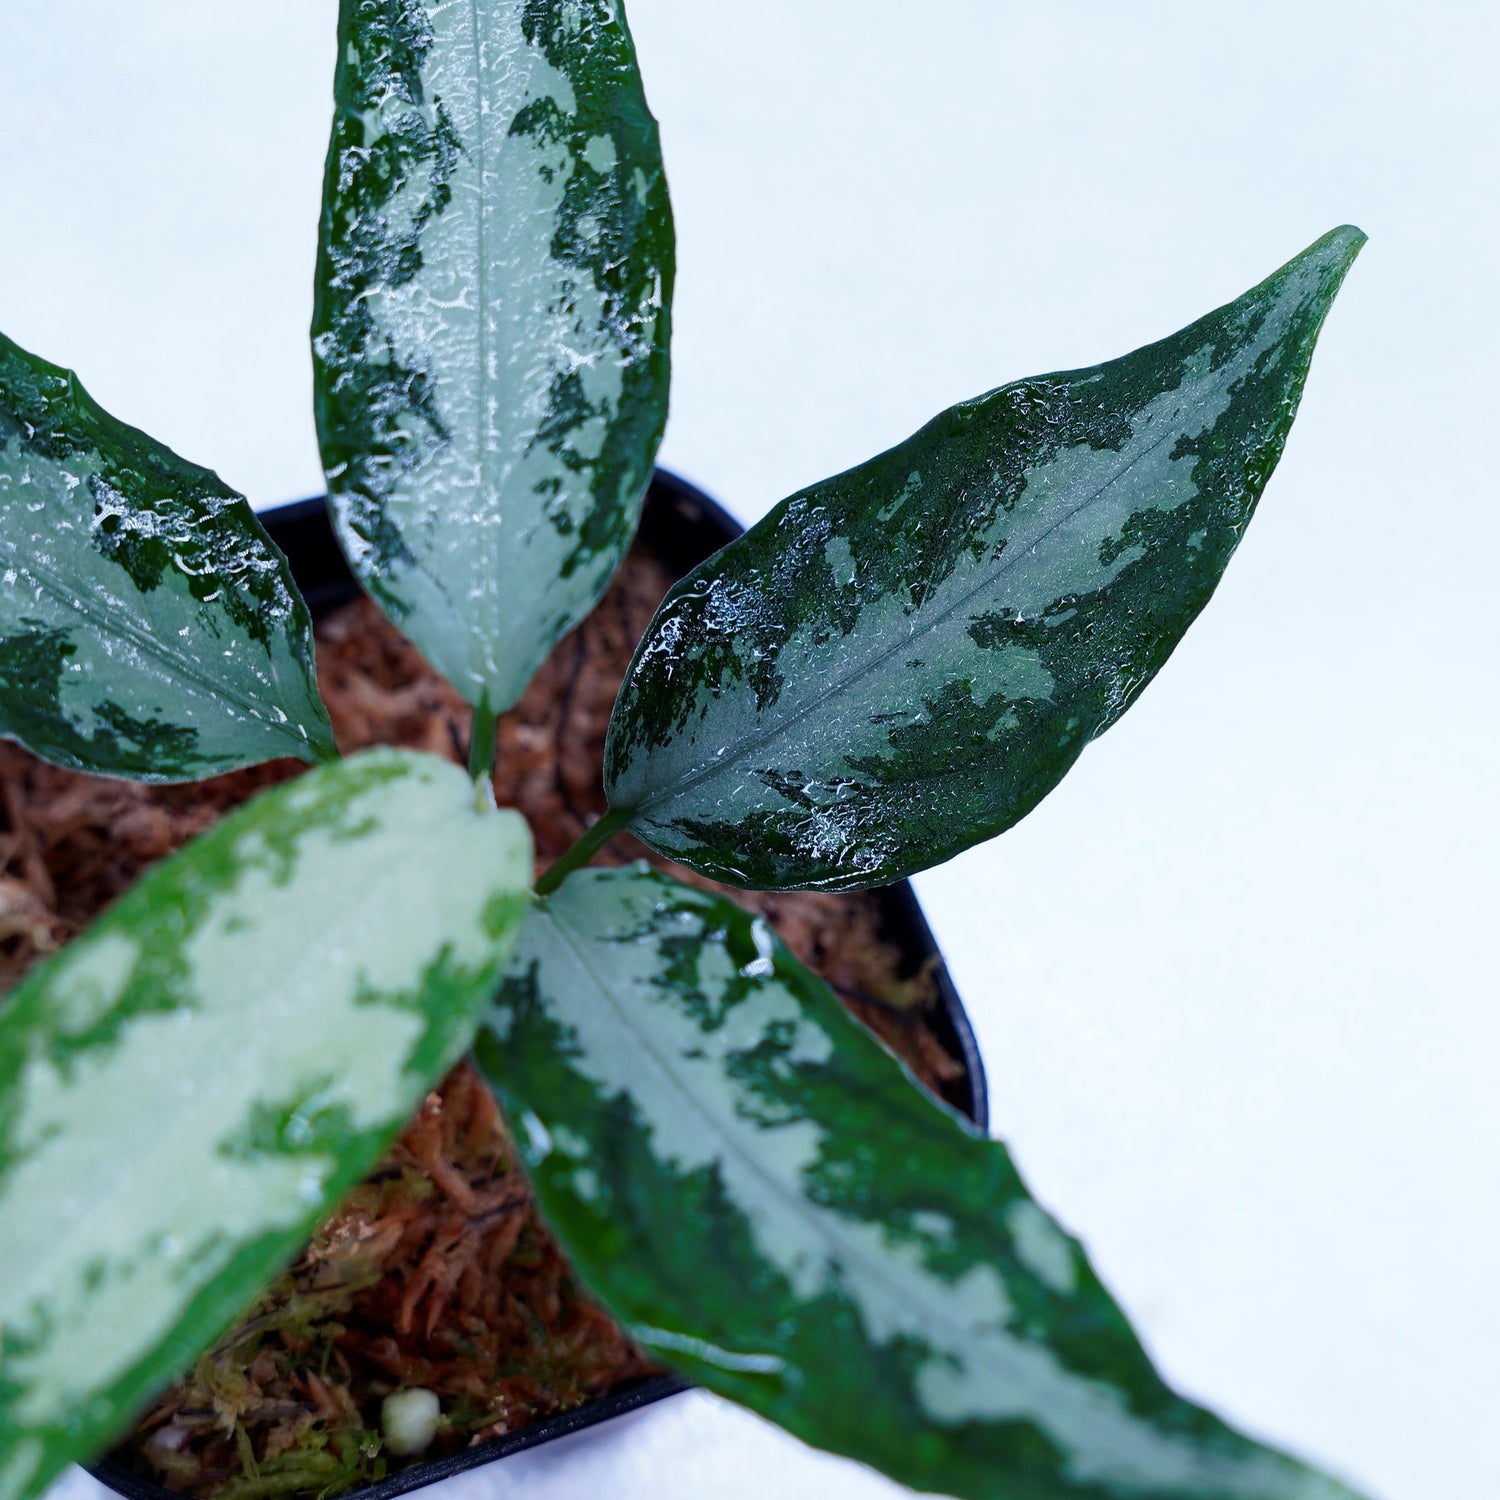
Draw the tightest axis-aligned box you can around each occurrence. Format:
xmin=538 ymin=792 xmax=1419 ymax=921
xmin=0 ymin=750 xmax=531 ymax=1500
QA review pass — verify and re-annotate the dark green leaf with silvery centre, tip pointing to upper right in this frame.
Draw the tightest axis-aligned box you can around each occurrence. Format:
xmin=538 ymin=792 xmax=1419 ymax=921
xmin=606 ymin=228 xmax=1365 ymax=890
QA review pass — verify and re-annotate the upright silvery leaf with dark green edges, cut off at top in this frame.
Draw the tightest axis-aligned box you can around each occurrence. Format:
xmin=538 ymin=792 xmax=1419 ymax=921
xmin=314 ymin=0 xmax=674 ymax=711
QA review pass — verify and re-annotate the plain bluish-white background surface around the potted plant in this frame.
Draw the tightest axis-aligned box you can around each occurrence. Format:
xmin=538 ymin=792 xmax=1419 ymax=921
xmin=0 ymin=0 xmax=1500 ymax=1500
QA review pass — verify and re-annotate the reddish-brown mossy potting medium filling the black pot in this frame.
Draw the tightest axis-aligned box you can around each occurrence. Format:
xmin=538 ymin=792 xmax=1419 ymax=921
xmin=0 ymin=546 xmax=965 ymax=1500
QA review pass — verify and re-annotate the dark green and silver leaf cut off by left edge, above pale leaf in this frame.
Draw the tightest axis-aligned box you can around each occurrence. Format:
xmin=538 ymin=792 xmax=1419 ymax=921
xmin=0 ymin=336 xmax=336 ymax=782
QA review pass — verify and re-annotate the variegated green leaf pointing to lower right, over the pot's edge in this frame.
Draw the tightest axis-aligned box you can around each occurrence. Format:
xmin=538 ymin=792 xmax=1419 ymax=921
xmin=476 ymin=866 xmax=1352 ymax=1500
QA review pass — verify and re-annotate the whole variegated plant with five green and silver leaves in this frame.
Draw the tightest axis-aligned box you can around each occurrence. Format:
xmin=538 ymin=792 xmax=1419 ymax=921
xmin=0 ymin=0 xmax=1364 ymax=1500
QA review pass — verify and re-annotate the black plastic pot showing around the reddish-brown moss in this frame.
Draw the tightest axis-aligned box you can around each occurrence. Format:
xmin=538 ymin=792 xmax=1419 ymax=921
xmin=90 ymin=470 xmax=989 ymax=1500
